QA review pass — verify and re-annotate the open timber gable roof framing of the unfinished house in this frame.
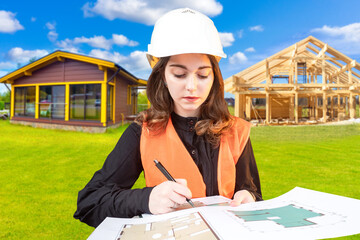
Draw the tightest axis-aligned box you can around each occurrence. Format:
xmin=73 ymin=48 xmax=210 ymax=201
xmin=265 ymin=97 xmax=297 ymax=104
xmin=225 ymin=36 xmax=360 ymax=92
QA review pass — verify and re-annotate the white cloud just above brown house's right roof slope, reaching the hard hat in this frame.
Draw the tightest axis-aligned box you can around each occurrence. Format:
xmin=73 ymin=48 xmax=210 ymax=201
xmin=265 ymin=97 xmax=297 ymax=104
xmin=89 ymin=49 xmax=151 ymax=76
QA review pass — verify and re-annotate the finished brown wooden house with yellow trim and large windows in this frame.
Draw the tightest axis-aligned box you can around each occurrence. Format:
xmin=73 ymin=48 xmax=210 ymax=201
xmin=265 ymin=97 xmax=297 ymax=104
xmin=0 ymin=51 xmax=146 ymax=131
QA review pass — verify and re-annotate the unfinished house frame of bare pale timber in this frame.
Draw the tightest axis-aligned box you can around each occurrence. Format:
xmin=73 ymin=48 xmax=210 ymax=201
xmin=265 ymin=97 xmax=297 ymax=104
xmin=225 ymin=36 xmax=360 ymax=124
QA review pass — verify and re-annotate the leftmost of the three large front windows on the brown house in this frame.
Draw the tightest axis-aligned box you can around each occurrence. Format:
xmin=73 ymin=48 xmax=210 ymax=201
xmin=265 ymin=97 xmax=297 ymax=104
xmin=15 ymin=87 xmax=35 ymax=117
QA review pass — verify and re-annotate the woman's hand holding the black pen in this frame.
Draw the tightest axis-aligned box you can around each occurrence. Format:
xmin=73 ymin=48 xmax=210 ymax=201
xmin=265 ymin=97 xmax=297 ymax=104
xmin=149 ymin=179 xmax=192 ymax=214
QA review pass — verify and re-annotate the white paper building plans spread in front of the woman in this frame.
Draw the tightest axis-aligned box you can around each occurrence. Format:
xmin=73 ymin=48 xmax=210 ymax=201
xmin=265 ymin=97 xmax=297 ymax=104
xmin=88 ymin=187 xmax=360 ymax=240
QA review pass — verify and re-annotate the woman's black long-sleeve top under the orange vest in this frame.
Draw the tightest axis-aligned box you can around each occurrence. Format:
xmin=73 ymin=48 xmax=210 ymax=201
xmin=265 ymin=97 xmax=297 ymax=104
xmin=74 ymin=113 xmax=262 ymax=227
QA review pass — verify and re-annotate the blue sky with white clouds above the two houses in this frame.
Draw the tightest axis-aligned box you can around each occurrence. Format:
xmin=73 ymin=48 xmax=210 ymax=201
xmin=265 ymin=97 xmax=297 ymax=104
xmin=0 ymin=0 xmax=360 ymax=96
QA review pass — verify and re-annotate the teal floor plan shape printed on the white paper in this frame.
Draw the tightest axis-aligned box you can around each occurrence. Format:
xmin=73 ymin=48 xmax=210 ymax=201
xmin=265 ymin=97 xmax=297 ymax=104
xmin=229 ymin=204 xmax=323 ymax=228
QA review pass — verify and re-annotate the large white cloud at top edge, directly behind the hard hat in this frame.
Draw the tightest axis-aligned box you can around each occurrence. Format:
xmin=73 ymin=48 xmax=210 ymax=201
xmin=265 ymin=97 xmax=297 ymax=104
xmin=82 ymin=0 xmax=223 ymax=25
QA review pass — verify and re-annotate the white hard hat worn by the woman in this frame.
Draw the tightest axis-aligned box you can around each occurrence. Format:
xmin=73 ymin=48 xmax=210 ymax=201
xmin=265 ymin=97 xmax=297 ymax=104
xmin=147 ymin=8 xmax=226 ymax=67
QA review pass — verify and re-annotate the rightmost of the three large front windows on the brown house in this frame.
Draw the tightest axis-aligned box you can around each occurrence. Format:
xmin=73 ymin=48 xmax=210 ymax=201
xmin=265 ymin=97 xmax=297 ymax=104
xmin=70 ymin=84 xmax=101 ymax=121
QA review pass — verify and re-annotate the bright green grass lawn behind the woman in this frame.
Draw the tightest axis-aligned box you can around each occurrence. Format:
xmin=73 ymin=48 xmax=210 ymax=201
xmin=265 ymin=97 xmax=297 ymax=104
xmin=0 ymin=121 xmax=360 ymax=239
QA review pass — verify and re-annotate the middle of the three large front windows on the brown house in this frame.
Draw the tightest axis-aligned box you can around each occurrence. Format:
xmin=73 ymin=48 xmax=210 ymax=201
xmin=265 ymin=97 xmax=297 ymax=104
xmin=39 ymin=86 xmax=65 ymax=119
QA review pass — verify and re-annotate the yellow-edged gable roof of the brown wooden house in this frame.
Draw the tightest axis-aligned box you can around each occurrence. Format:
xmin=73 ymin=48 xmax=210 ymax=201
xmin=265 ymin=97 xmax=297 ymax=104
xmin=0 ymin=50 xmax=147 ymax=85
